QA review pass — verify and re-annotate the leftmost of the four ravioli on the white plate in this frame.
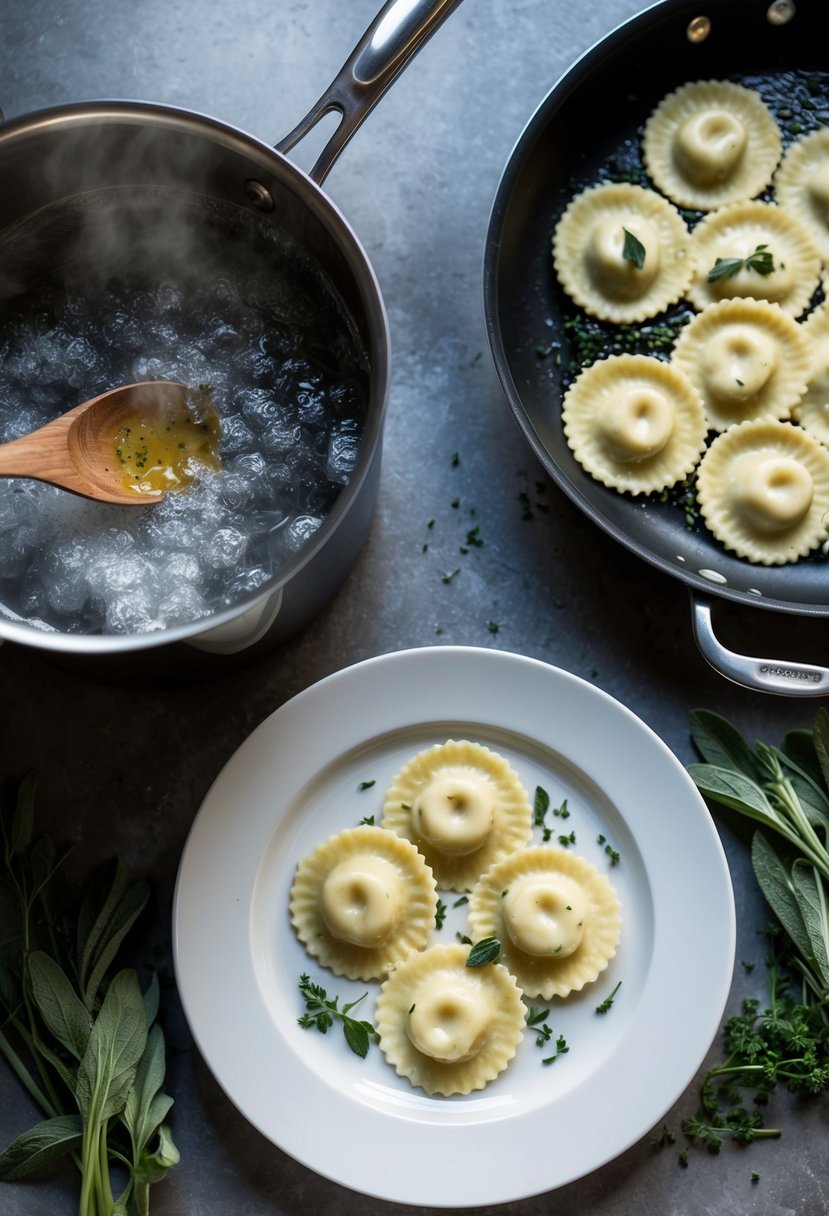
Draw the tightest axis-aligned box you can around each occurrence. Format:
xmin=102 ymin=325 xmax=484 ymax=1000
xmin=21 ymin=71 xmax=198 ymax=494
xmin=289 ymin=824 xmax=438 ymax=980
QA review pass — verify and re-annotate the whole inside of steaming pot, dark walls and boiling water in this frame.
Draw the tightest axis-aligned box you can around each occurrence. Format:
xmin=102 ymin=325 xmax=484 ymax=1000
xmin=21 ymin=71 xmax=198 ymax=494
xmin=0 ymin=107 xmax=385 ymax=649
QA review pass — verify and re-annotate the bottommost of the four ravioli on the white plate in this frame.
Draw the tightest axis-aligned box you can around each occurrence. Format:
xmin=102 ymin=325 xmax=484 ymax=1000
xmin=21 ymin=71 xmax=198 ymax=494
xmin=376 ymin=945 xmax=525 ymax=1097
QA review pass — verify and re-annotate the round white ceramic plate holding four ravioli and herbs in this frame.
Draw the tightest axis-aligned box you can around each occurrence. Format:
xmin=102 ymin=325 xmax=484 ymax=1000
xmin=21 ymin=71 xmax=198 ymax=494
xmin=174 ymin=647 xmax=734 ymax=1207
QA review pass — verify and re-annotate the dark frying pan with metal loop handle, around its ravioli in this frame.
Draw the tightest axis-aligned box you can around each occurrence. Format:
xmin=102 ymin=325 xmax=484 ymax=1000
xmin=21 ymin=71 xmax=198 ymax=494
xmin=484 ymin=0 xmax=829 ymax=696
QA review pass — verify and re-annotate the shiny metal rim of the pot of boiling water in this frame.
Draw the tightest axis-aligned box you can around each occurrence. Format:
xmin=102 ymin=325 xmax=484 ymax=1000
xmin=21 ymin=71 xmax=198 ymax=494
xmin=0 ymin=98 xmax=391 ymax=654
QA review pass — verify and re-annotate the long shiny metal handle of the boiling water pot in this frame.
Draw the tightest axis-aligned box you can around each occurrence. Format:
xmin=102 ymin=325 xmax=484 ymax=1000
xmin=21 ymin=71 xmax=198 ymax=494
xmin=276 ymin=0 xmax=461 ymax=186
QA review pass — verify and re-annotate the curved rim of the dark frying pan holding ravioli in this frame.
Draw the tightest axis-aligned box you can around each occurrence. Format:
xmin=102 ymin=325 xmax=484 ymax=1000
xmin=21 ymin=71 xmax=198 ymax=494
xmin=483 ymin=0 xmax=829 ymax=617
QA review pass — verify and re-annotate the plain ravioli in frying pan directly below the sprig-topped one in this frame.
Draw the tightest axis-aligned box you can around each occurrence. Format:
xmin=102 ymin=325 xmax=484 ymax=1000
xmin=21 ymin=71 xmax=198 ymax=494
xmin=672 ymin=299 xmax=810 ymax=430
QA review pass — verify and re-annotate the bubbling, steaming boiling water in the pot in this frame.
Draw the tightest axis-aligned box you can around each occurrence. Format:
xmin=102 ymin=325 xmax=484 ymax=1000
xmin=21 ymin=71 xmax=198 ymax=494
xmin=0 ymin=191 xmax=366 ymax=634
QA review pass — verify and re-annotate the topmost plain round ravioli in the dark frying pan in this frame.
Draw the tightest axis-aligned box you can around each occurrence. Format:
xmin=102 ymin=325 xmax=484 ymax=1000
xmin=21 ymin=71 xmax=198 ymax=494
xmin=642 ymin=80 xmax=782 ymax=212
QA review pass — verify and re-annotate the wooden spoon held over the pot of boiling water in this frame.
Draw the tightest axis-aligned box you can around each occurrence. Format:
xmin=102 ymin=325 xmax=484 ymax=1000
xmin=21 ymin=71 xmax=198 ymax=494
xmin=0 ymin=381 xmax=191 ymax=507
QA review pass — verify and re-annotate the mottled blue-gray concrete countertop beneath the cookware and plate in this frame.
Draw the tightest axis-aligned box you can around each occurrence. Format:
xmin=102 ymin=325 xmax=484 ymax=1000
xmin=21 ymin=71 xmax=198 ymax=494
xmin=0 ymin=0 xmax=829 ymax=1216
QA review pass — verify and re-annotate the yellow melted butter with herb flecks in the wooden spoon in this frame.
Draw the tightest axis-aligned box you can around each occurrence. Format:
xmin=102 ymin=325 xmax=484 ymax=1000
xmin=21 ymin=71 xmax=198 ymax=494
xmin=114 ymin=388 xmax=221 ymax=494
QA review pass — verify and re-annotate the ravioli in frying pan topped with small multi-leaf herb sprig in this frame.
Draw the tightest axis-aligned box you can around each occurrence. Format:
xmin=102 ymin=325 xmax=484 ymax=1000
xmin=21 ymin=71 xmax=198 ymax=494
xmin=687 ymin=202 xmax=820 ymax=316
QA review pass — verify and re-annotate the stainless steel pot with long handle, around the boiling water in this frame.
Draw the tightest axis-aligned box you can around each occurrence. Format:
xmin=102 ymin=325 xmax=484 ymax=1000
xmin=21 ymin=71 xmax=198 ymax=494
xmin=0 ymin=0 xmax=459 ymax=668
